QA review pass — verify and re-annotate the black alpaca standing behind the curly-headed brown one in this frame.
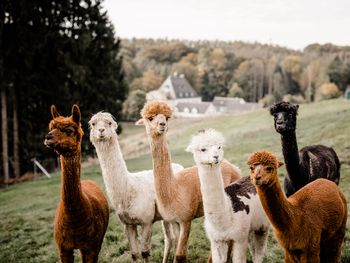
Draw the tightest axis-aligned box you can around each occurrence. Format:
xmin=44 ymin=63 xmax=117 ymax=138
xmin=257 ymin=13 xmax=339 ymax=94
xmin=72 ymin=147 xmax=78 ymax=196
xmin=270 ymin=101 xmax=340 ymax=197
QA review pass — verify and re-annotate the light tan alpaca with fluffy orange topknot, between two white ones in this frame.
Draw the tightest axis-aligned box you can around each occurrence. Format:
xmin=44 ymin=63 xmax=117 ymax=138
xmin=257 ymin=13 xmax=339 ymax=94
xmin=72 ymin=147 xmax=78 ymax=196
xmin=136 ymin=102 xmax=241 ymax=262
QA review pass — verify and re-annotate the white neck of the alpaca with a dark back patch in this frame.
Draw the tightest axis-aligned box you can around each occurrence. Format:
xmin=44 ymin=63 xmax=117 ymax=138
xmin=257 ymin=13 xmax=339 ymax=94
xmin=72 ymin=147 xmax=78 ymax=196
xmin=197 ymin=164 xmax=232 ymax=222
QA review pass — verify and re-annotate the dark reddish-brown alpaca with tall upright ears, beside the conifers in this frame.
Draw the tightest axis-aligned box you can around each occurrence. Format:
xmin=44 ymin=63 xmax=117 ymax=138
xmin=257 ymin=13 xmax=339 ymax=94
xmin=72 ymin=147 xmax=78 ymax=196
xmin=45 ymin=105 xmax=109 ymax=263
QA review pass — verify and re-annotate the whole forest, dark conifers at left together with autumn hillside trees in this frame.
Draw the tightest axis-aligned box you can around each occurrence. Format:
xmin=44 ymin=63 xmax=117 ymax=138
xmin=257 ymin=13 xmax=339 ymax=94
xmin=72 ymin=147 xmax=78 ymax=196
xmin=0 ymin=0 xmax=350 ymax=182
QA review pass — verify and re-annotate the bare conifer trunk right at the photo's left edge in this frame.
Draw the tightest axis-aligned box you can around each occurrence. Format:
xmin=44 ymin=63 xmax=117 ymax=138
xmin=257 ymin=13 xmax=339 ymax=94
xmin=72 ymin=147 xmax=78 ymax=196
xmin=1 ymin=88 xmax=10 ymax=184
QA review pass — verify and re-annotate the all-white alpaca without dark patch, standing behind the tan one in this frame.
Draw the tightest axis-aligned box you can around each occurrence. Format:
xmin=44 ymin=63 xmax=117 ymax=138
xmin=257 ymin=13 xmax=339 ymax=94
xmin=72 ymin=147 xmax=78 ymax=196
xmin=89 ymin=112 xmax=184 ymax=262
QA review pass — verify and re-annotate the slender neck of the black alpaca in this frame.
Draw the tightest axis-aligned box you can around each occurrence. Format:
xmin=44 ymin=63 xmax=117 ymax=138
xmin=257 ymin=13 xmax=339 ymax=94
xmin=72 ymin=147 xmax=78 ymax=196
xmin=281 ymin=131 xmax=304 ymax=188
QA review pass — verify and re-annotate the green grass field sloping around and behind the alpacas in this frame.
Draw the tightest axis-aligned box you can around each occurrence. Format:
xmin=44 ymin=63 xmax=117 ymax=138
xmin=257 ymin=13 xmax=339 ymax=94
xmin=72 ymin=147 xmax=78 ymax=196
xmin=0 ymin=99 xmax=350 ymax=263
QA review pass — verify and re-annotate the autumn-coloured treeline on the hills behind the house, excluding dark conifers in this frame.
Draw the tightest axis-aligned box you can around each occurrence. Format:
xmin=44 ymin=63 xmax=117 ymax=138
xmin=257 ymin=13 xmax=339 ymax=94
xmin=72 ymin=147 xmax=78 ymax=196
xmin=122 ymin=39 xmax=350 ymax=105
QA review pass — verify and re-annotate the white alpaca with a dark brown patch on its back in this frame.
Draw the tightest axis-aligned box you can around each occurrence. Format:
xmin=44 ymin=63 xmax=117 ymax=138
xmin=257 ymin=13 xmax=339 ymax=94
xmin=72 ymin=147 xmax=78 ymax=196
xmin=186 ymin=129 xmax=270 ymax=263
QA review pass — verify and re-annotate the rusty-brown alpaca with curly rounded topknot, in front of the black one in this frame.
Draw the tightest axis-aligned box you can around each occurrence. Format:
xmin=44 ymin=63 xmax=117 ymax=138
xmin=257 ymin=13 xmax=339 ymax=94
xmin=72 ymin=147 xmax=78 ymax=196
xmin=248 ymin=151 xmax=347 ymax=263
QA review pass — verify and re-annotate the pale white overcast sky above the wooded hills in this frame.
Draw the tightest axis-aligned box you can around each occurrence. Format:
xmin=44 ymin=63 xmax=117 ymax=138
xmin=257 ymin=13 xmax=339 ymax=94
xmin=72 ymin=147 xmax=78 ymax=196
xmin=104 ymin=0 xmax=350 ymax=49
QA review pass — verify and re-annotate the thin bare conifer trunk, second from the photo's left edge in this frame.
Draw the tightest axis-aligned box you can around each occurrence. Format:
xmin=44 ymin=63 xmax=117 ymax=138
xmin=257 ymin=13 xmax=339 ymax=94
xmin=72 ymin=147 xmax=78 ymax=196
xmin=12 ymin=87 xmax=21 ymax=178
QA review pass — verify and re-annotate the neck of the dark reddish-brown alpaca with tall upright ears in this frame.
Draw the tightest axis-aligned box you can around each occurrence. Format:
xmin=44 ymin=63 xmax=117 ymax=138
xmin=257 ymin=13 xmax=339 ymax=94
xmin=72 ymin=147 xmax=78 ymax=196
xmin=60 ymin=151 xmax=83 ymax=212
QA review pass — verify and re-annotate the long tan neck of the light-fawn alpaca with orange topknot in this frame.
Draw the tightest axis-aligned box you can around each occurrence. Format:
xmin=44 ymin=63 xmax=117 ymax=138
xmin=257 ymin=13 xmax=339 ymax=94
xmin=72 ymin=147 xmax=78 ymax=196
xmin=150 ymin=135 xmax=174 ymax=205
